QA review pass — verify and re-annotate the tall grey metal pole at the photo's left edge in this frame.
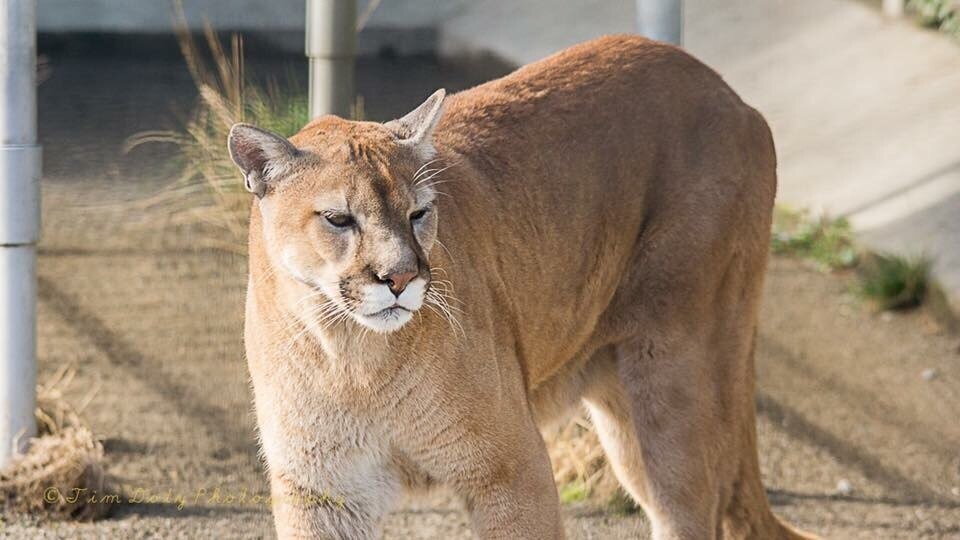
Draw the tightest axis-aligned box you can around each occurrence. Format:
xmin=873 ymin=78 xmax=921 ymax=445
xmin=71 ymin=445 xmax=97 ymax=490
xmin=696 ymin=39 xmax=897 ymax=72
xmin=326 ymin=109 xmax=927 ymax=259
xmin=0 ymin=0 xmax=40 ymax=467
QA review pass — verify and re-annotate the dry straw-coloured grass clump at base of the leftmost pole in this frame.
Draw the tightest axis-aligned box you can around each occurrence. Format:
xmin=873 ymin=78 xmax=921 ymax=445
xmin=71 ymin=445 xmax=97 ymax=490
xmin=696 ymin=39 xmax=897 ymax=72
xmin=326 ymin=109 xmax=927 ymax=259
xmin=0 ymin=367 xmax=110 ymax=521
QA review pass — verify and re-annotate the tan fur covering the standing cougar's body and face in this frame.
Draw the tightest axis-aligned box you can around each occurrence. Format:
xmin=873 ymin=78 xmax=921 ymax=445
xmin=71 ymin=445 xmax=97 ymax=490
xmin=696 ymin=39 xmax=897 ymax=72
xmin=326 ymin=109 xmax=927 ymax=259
xmin=231 ymin=36 xmax=804 ymax=540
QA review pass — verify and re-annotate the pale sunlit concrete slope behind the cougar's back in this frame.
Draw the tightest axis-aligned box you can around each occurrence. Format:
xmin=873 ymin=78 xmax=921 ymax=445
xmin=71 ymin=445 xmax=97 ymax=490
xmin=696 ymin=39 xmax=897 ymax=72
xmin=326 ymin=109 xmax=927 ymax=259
xmin=438 ymin=0 xmax=960 ymax=308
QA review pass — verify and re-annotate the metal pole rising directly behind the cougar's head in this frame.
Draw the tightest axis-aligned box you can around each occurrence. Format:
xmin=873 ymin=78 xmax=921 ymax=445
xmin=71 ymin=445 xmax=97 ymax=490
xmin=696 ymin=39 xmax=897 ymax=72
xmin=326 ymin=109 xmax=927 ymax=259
xmin=306 ymin=0 xmax=357 ymax=118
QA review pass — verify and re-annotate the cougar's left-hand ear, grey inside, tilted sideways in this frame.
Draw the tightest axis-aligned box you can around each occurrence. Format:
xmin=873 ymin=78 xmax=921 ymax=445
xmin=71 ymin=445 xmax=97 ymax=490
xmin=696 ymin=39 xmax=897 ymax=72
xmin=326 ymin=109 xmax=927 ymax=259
xmin=227 ymin=124 xmax=300 ymax=198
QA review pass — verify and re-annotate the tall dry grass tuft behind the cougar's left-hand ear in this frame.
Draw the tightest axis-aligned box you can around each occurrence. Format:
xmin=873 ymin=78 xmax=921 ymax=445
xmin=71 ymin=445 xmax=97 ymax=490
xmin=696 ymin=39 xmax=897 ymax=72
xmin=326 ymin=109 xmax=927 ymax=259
xmin=126 ymin=1 xmax=308 ymax=252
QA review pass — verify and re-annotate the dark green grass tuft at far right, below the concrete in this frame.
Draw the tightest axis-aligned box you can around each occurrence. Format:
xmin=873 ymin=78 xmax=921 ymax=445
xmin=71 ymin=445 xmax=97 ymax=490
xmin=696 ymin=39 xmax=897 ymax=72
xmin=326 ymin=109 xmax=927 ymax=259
xmin=860 ymin=254 xmax=930 ymax=310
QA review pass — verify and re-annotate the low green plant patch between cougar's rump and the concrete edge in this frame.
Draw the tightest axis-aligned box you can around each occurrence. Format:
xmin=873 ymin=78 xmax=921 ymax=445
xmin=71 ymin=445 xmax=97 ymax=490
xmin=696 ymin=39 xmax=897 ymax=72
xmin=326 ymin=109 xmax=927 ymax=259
xmin=771 ymin=207 xmax=857 ymax=270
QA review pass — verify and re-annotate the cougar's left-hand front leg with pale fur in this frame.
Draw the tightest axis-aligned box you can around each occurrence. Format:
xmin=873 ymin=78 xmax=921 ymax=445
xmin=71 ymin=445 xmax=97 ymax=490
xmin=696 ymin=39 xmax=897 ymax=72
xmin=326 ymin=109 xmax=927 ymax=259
xmin=255 ymin=379 xmax=400 ymax=540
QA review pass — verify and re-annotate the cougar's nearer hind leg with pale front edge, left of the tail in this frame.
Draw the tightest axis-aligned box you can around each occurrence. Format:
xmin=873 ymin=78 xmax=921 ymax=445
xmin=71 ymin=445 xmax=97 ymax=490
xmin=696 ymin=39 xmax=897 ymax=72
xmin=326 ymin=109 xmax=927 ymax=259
xmin=583 ymin=340 xmax=720 ymax=540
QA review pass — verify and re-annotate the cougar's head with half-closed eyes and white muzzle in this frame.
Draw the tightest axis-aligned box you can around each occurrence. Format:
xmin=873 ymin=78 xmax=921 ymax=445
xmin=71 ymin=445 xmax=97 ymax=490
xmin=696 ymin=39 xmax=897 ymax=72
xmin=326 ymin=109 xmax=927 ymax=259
xmin=228 ymin=90 xmax=445 ymax=333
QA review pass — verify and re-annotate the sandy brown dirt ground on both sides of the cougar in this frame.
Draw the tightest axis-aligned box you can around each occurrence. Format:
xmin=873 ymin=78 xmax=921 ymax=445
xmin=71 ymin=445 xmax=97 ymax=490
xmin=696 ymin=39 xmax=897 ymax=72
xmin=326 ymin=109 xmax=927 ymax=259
xmin=0 ymin=40 xmax=960 ymax=539
